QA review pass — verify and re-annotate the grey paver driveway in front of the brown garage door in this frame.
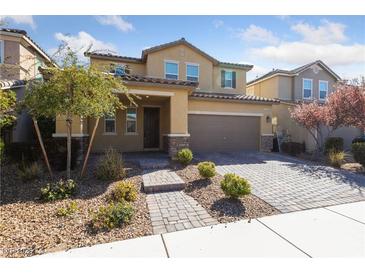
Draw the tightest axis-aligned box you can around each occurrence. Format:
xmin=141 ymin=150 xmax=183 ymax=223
xmin=196 ymin=152 xmax=365 ymax=212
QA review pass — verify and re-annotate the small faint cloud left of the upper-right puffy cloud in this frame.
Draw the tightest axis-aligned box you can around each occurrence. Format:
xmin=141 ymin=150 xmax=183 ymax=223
xmin=238 ymin=25 xmax=280 ymax=44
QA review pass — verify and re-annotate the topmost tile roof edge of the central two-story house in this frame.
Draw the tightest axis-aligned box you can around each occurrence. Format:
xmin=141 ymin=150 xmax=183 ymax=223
xmin=84 ymin=38 xmax=253 ymax=69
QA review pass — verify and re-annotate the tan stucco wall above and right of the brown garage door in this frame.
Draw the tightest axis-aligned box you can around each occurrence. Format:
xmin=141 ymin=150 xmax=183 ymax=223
xmin=189 ymin=99 xmax=272 ymax=134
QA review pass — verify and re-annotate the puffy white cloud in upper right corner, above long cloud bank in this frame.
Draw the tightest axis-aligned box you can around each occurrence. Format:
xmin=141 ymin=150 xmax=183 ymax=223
xmin=291 ymin=20 xmax=347 ymax=45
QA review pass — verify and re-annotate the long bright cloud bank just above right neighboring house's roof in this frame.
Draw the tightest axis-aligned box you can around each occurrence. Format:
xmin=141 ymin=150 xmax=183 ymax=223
xmin=250 ymin=42 xmax=365 ymax=66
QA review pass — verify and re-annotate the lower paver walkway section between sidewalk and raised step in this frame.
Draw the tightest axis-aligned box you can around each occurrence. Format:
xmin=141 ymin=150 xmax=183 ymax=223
xmin=147 ymin=191 xmax=218 ymax=234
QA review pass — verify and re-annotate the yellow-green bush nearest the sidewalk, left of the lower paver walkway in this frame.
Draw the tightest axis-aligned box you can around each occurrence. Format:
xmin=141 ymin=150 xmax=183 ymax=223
xmin=91 ymin=202 xmax=134 ymax=230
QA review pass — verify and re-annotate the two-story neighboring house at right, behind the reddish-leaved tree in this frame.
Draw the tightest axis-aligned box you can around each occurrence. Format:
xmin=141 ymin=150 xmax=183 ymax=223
xmin=247 ymin=60 xmax=361 ymax=151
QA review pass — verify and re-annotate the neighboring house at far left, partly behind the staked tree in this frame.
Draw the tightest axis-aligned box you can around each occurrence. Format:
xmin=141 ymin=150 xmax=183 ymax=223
xmin=0 ymin=28 xmax=55 ymax=143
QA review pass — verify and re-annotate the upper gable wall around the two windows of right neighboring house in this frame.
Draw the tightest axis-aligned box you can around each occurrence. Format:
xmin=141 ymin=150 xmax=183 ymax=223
xmin=294 ymin=68 xmax=336 ymax=100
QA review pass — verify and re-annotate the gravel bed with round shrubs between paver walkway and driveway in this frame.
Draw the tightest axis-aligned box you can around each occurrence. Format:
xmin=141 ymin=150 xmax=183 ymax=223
xmin=176 ymin=165 xmax=280 ymax=223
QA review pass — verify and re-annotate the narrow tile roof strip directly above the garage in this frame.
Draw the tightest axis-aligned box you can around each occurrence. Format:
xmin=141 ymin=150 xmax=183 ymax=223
xmin=190 ymin=92 xmax=280 ymax=103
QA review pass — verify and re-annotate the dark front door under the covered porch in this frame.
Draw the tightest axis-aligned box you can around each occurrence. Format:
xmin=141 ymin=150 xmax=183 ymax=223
xmin=143 ymin=107 xmax=160 ymax=148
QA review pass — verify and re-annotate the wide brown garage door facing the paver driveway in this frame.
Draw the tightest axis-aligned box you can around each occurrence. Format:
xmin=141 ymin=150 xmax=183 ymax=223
xmin=189 ymin=114 xmax=260 ymax=152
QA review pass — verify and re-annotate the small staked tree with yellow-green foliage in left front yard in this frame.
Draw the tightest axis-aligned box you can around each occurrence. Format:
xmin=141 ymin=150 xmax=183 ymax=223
xmin=25 ymin=48 xmax=133 ymax=178
